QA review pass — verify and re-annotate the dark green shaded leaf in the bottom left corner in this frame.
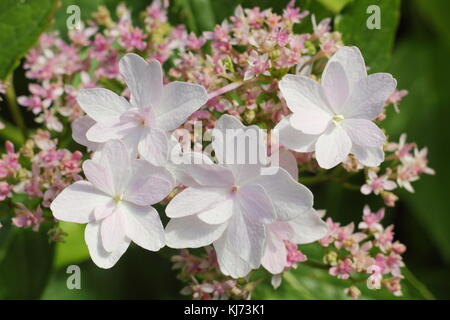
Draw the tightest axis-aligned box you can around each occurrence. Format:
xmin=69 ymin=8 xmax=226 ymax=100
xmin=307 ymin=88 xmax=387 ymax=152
xmin=0 ymin=226 xmax=54 ymax=299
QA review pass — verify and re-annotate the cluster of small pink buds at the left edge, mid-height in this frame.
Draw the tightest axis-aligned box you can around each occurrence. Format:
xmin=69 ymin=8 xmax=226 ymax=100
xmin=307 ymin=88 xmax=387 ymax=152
xmin=0 ymin=130 xmax=82 ymax=238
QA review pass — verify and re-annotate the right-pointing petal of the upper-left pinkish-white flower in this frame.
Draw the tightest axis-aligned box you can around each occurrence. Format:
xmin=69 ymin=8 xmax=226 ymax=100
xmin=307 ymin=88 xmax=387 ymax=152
xmin=155 ymin=81 xmax=208 ymax=131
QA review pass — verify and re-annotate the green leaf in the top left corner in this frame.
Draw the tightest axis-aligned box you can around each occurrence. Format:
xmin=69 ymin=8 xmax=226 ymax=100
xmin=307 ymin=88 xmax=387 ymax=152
xmin=0 ymin=0 xmax=56 ymax=79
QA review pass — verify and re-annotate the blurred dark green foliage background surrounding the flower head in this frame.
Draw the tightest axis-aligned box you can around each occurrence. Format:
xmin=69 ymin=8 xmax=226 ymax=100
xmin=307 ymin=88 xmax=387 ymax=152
xmin=0 ymin=0 xmax=450 ymax=299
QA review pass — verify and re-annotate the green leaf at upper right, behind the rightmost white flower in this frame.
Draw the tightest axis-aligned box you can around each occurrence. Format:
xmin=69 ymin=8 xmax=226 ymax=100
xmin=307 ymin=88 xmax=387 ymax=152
xmin=335 ymin=0 xmax=400 ymax=73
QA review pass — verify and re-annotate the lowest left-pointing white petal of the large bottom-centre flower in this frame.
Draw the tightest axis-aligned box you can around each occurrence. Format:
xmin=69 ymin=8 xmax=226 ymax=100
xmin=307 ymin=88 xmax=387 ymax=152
xmin=165 ymin=215 xmax=227 ymax=249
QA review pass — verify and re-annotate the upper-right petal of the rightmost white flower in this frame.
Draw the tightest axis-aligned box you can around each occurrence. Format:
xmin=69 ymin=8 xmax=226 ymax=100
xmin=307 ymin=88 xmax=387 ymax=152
xmin=342 ymin=73 xmax=397 ymax=120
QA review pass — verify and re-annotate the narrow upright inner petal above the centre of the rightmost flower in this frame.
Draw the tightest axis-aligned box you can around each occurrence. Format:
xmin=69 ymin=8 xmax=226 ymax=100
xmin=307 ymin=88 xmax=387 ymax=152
xmin=321 ymin=61 xmax=350 ymax=114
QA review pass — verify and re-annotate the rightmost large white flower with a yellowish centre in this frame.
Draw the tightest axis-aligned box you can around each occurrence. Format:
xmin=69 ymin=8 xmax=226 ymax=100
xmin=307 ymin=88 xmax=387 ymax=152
xmin=277 ymin=47 xmax=396 ymax=169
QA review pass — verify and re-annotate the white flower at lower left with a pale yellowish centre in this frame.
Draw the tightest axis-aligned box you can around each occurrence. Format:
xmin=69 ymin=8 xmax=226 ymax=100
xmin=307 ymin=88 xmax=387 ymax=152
xmin=50 ymin=141 xmax=174 ymax=268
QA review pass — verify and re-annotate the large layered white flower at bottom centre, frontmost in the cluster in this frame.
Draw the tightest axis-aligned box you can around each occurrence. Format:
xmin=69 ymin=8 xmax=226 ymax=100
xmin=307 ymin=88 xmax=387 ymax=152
xmin=166 ymin=115 xmax=323 ymax=278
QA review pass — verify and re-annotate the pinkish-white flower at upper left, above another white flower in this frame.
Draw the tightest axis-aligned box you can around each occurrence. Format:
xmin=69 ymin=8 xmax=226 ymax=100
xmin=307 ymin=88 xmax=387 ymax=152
xmin=77 ymin=53 xmax=208 ymax=165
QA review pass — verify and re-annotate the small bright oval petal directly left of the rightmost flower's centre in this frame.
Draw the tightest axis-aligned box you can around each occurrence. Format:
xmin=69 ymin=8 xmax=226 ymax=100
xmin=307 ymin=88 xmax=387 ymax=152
xmin=289 ymin=109 xmax=332 ymax=134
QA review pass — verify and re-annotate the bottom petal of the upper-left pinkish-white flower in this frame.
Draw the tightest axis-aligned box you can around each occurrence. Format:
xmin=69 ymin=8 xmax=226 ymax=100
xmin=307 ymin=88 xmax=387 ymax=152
xmin=138 ymin=128 xmax=169 ymax=166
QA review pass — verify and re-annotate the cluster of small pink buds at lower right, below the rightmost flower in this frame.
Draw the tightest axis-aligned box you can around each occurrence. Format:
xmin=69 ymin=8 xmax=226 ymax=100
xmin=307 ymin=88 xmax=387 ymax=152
xmin=319 ymin=206 xmax=406 ymax=298
